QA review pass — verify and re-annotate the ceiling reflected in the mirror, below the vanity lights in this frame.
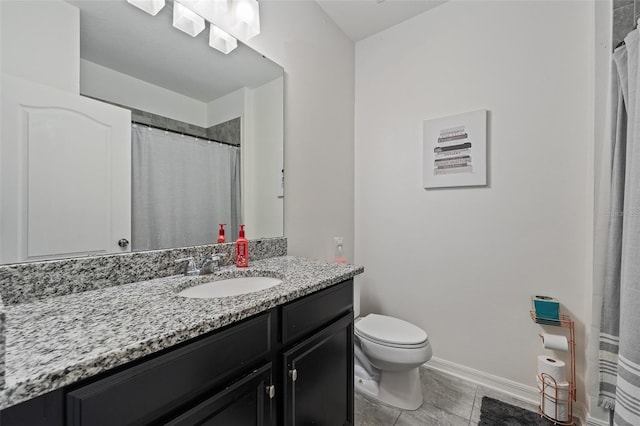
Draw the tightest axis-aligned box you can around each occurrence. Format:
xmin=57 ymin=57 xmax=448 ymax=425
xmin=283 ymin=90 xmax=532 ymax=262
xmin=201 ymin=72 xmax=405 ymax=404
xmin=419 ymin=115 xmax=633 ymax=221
xmin=67 ymin=0 xmax=283 ymax=102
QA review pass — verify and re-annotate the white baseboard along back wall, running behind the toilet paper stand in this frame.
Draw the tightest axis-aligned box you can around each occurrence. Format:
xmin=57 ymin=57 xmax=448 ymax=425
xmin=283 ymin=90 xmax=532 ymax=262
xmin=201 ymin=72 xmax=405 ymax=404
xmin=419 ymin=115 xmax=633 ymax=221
xmin=424 ymin=357 xmax=596 ymax=426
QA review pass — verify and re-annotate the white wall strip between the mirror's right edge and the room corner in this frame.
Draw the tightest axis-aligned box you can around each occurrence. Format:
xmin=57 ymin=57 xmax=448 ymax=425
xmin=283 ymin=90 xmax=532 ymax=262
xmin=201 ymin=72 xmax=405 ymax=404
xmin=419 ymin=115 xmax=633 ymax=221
xmin=248 ymin=0 xmax=354 ymax=261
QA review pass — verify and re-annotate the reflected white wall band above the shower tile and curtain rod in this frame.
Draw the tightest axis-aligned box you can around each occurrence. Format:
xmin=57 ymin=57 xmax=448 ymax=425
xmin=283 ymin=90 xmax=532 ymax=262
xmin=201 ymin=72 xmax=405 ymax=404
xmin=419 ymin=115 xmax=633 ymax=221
xmin=80 ymin=59 xmax=208 ymax=127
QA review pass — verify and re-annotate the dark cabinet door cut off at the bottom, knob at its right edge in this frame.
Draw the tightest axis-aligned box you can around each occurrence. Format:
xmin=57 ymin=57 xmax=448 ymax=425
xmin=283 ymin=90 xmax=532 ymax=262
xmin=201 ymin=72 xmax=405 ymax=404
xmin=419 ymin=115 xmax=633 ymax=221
xmin=167 ymin=363 xmax=275 ymax=426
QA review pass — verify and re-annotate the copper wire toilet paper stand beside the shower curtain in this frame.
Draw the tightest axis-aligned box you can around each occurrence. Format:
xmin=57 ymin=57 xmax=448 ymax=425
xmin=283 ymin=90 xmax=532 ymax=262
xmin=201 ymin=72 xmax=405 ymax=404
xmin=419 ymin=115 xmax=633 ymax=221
xmin=530 ymin=311 xmax=576 ymax=425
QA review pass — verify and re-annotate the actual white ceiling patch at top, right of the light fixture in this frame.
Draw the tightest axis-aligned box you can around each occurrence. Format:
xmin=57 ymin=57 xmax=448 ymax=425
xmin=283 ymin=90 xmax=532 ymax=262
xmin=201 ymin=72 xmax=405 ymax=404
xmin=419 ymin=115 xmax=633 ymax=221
xmin=316 ymin=0 xmax=446 ymax=41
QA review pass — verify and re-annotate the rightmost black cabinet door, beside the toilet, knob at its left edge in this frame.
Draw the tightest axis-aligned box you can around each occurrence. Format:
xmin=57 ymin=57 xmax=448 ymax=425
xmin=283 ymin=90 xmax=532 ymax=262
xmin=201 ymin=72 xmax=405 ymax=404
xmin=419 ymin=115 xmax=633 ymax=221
xmin=283 ymin=313 xmax=353 ymax=426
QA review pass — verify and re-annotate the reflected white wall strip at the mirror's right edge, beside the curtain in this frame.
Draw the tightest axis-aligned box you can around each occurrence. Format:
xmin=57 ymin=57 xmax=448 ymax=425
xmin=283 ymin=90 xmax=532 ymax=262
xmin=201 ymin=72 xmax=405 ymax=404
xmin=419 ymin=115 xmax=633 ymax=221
xmin=242 ymin=78 xmax=284 ymax=236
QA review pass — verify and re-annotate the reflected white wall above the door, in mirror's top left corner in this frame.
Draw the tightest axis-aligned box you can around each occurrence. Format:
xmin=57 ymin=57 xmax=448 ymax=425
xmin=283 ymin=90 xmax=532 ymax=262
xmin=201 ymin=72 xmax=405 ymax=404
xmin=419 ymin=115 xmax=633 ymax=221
xmin=0 ymin=0 xmax=80 ymax=93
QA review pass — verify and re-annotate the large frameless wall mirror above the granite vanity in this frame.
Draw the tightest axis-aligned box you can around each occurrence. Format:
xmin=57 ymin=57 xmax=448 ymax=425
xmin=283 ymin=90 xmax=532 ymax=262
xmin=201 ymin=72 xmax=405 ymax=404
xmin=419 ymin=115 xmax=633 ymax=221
xmin=0 ymin=0 xmax=284 ymax=263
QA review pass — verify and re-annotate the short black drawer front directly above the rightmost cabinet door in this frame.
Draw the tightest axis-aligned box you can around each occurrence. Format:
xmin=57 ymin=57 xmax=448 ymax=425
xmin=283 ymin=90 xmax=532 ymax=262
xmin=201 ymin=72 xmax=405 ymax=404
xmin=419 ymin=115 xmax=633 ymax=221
xmin=281 ymin=280 xmax=353 ymax=344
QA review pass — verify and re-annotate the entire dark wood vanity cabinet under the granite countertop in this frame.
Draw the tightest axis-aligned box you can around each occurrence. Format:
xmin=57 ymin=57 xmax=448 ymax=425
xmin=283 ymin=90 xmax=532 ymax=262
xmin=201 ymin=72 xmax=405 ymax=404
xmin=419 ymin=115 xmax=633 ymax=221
xmin=0 ymin=280 xmax=353 ymax=426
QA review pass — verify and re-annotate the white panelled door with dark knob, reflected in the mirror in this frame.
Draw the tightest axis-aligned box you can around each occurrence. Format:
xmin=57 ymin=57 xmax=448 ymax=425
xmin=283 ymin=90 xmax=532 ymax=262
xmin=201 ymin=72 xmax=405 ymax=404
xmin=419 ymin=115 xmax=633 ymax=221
xmin=0 ymin=74 xmax=131 ymax=264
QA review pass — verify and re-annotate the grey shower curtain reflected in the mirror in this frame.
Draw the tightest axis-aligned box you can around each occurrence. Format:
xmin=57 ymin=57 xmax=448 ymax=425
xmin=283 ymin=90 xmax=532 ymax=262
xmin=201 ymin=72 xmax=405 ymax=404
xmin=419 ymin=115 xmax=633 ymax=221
xmin=131 ymin=124 xmax=241 ymax=250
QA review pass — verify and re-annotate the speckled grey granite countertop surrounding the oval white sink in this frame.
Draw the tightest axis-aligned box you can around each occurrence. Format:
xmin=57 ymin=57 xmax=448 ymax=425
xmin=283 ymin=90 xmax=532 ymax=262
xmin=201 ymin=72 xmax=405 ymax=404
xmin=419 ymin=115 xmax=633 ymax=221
xmin=0 ymin=256 xmax=363 ymax=409
